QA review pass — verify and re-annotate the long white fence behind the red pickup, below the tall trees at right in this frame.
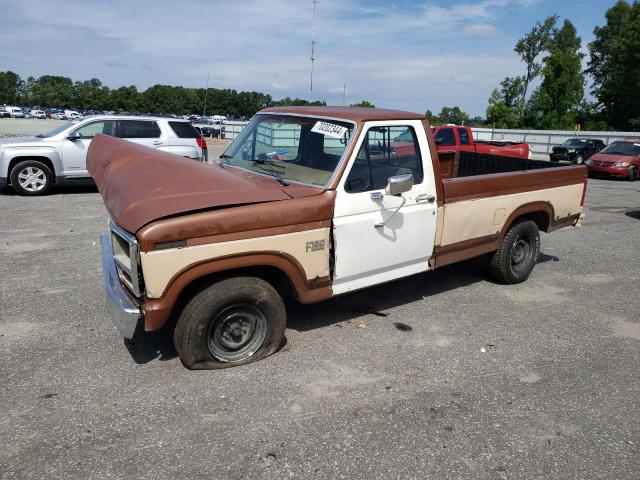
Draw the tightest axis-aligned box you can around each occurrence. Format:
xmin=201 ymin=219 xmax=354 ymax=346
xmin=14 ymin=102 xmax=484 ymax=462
xmin=471 ymin=128 xmax=640 ymax=154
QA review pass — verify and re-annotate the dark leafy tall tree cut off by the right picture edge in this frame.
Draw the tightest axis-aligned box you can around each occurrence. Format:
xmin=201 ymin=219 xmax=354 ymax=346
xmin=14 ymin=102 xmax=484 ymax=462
xmin=587 ymin=0 xmax=640 ymax=130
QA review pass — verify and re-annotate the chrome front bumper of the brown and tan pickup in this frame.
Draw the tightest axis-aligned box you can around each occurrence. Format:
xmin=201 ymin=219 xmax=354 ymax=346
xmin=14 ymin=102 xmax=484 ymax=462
xmin=100 ymin=232 xmax=142 ymax=338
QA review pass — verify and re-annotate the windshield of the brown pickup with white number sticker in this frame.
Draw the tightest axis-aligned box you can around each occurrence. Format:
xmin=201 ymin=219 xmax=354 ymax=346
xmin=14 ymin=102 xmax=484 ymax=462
xmin=219 ymin=114 xmax=354 ymax=187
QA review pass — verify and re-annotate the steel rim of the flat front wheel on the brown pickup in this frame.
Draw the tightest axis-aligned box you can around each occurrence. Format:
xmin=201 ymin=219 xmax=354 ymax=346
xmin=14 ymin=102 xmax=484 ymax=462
xmin=207 ymin=303 xmax=267 ymax=362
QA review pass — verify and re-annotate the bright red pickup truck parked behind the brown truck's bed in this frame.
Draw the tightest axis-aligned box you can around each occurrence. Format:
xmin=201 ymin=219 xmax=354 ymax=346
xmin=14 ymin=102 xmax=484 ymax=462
xmin=433 ymin=125 xmax=531 ymax=158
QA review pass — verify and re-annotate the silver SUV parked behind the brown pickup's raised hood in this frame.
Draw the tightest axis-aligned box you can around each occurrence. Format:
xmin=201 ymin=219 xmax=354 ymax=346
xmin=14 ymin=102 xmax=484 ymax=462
xmin=0 ymin=116 xmax=207 ymax=195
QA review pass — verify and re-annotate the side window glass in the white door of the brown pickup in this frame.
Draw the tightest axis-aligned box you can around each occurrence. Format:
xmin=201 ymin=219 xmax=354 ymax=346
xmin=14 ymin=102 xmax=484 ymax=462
xmin=345 ymin=126 xmax=424 ymax=193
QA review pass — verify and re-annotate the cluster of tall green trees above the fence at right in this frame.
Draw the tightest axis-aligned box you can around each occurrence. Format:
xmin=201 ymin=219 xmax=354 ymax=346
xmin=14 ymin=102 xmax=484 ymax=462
xmin=486 ymin=0 xmax=640 ymax=131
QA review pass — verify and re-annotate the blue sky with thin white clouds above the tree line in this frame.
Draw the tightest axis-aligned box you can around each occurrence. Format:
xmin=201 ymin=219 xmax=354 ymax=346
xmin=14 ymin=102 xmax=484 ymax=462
xmin=0 ymin=0 xmax=615 ymax=116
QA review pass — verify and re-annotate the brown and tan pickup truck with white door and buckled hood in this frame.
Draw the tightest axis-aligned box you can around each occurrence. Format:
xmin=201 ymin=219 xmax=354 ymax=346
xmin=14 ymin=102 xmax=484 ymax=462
xmin=88 ymin=107 xmax=587 ymax=368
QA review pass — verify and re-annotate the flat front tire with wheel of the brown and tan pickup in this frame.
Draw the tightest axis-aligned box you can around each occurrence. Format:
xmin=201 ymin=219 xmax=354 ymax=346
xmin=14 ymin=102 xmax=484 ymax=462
xmin=173 ymin=277 xmax=287 ymax=370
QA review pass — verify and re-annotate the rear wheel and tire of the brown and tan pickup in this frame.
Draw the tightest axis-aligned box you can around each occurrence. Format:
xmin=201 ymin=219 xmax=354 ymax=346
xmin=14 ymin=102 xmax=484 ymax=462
xmin=490 ymin=219 xmax=540 ymax=284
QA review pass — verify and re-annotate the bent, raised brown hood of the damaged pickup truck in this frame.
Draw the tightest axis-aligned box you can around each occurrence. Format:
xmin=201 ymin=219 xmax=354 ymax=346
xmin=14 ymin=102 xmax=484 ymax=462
xmin=87 ymin=134 xmax=323 ymax=233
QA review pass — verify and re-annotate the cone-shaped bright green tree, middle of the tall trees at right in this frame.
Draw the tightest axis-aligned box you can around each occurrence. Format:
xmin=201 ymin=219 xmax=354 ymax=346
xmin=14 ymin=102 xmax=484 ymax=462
xmin=529 ymin=20 xmax=584 ymax=129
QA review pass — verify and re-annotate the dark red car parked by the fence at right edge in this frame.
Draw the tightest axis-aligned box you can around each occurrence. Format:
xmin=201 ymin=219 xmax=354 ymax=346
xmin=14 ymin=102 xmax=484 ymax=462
xmin=585 ymin=138 xmax=640 ymax=182
